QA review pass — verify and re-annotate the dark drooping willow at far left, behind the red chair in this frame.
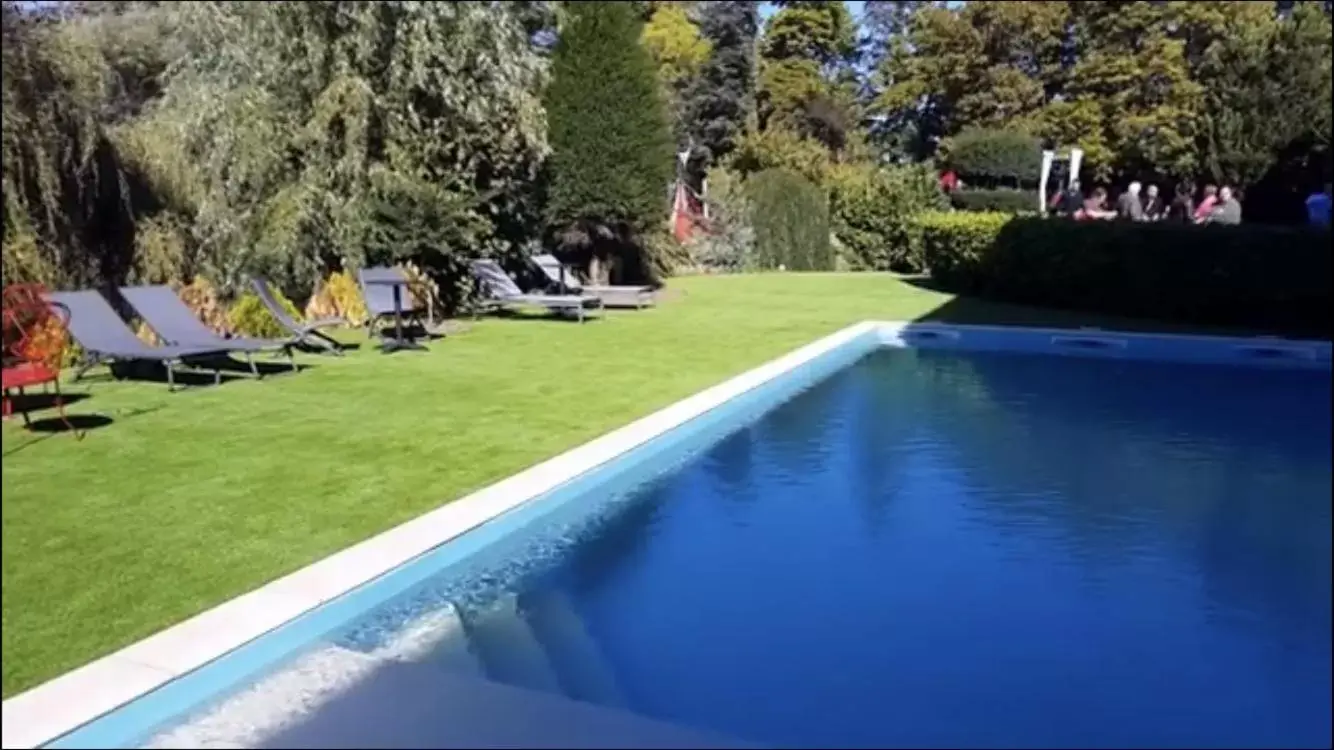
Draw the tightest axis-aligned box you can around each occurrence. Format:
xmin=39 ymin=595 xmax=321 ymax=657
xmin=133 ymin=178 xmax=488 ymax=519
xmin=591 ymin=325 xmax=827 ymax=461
xmin=3 ymin=1 xmax=141 ymax=287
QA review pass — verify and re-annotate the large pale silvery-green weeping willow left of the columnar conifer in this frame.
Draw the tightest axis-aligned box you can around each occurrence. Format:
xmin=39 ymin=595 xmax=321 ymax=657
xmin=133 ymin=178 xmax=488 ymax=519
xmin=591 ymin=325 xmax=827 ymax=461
xmin=121 ymin=1 xmax=547 ymax=306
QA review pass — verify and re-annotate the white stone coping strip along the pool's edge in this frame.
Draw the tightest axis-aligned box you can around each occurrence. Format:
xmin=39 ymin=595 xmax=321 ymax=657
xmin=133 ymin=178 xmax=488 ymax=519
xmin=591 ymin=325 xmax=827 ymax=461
xmin=0 ymin=322 xmax=1330 ymax=749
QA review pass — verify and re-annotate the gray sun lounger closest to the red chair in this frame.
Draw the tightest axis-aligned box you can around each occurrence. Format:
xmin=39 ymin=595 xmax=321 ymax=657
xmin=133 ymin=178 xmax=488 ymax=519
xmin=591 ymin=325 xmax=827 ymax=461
xmin=45 ymin=290 xmax=232 ymax=390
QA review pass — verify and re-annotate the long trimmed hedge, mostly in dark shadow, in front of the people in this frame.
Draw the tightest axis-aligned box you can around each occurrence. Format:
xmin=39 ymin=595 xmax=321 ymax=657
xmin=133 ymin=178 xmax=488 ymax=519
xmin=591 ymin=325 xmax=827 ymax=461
xmin=918 ymin=214 xmax=1334 ymax=339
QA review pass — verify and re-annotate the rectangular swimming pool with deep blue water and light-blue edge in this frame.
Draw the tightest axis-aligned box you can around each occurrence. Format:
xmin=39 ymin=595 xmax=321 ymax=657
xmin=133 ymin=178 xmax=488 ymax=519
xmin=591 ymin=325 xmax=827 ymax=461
xmin=13 ymin=327 xmax=1331 ymax=746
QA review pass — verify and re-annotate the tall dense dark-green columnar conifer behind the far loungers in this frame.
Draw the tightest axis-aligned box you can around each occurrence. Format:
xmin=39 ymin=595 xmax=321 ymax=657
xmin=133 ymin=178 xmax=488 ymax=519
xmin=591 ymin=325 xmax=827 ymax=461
xmin=546 ymin=1 xmax=674 ymax=283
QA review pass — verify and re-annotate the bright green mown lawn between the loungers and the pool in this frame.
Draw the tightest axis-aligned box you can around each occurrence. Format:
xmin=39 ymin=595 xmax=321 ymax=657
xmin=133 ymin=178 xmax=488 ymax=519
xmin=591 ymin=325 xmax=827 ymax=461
xmin=0 ymin=274 xmax=1237 ymax=697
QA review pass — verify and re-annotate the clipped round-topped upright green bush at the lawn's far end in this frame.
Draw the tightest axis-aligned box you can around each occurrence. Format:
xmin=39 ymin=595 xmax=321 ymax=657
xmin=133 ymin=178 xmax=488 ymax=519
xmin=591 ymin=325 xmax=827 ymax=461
xmin=747 ymin=169 xmax=834 ymax=271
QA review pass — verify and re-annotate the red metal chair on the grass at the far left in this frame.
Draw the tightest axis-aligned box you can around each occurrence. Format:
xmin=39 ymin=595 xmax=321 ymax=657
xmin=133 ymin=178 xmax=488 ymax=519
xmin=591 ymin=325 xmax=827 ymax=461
xmin=0 ymin=284 xmax=83 ymax=438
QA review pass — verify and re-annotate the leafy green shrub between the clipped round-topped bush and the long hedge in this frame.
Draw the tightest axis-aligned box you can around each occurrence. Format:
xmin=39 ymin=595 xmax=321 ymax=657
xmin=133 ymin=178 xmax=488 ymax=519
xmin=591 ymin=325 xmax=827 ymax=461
xmin=830 ymin=167 xmax=946 ymax=272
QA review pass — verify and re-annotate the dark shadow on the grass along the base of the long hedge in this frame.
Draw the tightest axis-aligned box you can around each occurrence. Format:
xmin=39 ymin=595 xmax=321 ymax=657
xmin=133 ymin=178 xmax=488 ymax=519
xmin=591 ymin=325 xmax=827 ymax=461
xmin=899 ymin=276 xmax=1270 ymax=336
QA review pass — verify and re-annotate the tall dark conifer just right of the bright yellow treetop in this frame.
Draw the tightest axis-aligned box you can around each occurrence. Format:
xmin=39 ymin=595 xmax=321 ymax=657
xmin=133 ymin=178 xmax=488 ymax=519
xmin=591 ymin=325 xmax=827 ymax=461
xmin=683 ymin=0 xmax=759 ymax=168
